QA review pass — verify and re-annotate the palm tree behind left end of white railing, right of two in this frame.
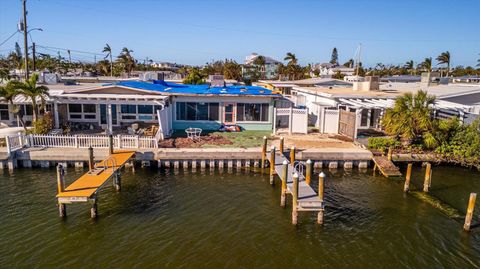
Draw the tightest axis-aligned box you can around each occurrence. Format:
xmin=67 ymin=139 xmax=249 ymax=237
xmin=14 ymin=74 xmax=49 ymax=121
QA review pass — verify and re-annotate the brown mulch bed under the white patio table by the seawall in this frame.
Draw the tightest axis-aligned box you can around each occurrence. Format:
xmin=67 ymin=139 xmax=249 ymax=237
xmin=159 ymin=134 xmax=233 ymax=148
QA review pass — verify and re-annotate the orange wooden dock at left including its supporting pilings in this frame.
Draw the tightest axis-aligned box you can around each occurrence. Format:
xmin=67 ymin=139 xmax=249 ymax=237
xmin=57 ymin=151 xmax=135 ymax=217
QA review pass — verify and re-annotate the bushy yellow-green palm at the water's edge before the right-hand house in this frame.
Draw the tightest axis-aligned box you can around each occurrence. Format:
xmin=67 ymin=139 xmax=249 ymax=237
xmin=383 ymin=91 xmax=435 ymax=145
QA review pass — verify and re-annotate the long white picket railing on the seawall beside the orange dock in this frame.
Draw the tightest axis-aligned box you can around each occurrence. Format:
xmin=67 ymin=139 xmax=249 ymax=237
xmin=24 ymin=135 xmax=158 ymax=149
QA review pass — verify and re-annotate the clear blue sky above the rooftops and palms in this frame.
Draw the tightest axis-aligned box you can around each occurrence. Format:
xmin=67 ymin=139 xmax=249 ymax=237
xmin=0 ymin=0 xmax=480 ymax=66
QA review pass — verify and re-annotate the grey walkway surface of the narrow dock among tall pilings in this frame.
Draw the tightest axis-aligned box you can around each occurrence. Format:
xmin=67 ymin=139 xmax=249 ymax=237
xmin=275 ymin=153 xmax=324 ymax=211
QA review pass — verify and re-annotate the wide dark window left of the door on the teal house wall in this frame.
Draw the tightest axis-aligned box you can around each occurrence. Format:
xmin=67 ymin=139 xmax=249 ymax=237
xmin=176 ymin=102 xmax=220 ymax=121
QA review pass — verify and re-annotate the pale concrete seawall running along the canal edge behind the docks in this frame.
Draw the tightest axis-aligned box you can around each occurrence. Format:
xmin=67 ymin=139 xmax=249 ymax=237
xmin=0 ymin=148 xmax=372 ymax=169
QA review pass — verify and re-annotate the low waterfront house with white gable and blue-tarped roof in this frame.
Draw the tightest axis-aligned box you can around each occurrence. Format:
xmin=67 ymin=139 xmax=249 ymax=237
xmin=0 ymin=80 xmax=280 ymax=134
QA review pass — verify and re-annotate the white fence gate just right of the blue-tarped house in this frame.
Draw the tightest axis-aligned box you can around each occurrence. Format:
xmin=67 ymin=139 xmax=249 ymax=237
xmin=273 ymin=107 xmax=308 ymax=134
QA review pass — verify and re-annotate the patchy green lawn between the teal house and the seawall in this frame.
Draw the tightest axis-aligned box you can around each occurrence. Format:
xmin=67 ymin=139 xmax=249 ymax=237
xmin=202 ymin=131 xmax=272 ymax=148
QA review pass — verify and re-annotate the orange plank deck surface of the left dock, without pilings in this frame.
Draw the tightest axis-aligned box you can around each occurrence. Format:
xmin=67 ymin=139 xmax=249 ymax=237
xmin=57 ymin=151 xmax=135 ymax=203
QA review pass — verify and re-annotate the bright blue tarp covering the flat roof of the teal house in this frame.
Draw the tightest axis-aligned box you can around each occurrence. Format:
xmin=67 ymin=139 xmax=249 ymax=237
xmin=109 ymin=80 xmax=279 ymax=96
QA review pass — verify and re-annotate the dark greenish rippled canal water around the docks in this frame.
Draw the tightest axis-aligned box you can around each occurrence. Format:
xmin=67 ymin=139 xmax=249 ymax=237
xmin=0 ymin=164 xmax=480 ymax=268
